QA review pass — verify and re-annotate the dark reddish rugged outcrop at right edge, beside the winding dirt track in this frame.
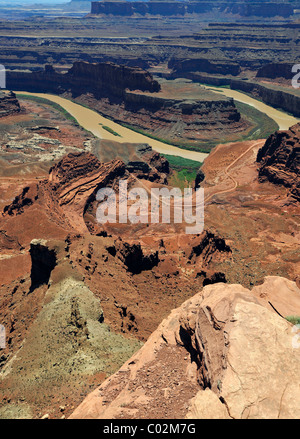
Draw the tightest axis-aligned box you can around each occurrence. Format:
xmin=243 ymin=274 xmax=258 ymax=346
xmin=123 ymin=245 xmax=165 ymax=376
xmin=257 ymin=124 xmax=300 ymax=201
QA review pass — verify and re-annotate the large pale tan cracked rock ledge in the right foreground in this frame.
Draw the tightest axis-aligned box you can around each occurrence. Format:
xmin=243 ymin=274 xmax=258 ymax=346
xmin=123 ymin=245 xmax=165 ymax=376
xmin=71 ymin=277 xmax=300 ymax=419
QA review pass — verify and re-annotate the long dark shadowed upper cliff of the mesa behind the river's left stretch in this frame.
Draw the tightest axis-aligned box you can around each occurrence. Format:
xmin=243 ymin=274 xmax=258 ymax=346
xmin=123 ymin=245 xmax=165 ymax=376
xmin=7 ymin=62 xmax=160 ymax=98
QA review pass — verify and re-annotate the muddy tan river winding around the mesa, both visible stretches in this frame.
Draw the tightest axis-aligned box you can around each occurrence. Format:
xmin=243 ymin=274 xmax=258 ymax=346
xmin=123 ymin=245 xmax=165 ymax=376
xmin=16 ymin=87 xmax=298 ymax=162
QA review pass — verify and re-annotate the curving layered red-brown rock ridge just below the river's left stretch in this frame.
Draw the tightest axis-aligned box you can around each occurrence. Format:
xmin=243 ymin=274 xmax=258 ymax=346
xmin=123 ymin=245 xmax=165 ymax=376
xmin=2 ymin=148 xmax=168 ymax=239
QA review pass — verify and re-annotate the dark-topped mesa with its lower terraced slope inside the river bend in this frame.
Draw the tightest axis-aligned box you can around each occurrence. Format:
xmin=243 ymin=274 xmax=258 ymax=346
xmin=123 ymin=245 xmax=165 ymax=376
xmin=7 ymin=62 xmax=245 ymax=142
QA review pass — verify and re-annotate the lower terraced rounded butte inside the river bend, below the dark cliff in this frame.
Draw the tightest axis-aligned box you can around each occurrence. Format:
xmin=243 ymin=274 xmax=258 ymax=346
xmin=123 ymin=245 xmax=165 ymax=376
xmin=91 ymin=91 xmax=241 ymax=144
